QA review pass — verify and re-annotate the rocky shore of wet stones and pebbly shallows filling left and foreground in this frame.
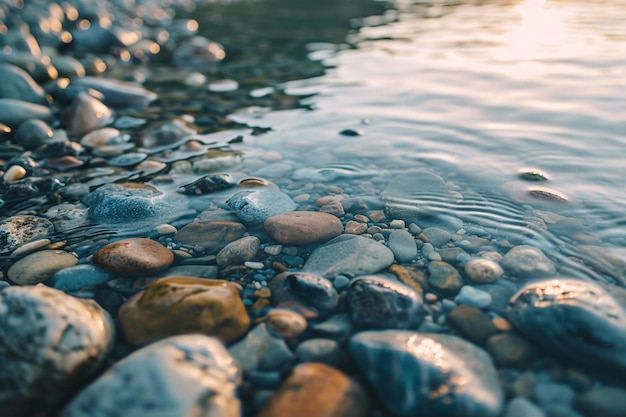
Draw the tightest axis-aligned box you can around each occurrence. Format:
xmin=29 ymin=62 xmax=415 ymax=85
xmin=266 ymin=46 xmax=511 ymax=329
xmin=0 ymin=1 xmax=626 ymax=417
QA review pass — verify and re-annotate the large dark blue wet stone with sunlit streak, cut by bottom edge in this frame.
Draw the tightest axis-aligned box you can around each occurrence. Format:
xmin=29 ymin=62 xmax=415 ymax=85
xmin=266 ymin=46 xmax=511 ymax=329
xmin=349 ymin=330 xmax=503 ymax=417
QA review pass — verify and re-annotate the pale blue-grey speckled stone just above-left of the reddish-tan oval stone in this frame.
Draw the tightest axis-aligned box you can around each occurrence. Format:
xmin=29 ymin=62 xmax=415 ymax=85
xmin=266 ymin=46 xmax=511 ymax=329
xmin=226 ymin=187 xmax=297 ymax=223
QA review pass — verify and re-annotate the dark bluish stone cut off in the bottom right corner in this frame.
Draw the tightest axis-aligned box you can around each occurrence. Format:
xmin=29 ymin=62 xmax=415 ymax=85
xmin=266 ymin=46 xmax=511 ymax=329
xmin=574 ymin=386 xmax=626 ymax=417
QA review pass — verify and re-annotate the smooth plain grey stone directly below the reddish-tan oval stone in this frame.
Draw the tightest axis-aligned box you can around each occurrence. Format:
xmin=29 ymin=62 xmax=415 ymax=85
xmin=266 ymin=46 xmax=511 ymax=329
xmin=302 ymin=235 xmax=394 ymax=276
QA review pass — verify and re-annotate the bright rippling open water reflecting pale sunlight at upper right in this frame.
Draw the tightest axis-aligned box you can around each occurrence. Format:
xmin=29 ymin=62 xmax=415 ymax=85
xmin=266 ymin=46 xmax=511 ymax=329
xmin=223 ymin=0 xmax=626 ymax=280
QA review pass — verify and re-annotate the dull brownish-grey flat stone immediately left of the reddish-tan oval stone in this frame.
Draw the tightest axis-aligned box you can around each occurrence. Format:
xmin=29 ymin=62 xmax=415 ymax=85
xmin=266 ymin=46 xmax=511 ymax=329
xmin=173 ymin=220 xmax=246 ymax=254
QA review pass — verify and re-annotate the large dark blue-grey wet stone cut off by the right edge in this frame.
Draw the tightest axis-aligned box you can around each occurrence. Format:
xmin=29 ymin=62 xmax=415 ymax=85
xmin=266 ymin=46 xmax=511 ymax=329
xmin=507 ymin=278 xmax=626 ymax=375
